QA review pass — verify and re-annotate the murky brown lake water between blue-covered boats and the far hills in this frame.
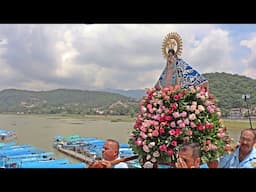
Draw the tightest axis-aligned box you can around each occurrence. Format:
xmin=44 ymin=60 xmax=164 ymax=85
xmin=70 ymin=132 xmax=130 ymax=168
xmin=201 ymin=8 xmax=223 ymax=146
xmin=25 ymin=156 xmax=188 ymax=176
xmin=0 ymin=115 xmax=134 ymax=162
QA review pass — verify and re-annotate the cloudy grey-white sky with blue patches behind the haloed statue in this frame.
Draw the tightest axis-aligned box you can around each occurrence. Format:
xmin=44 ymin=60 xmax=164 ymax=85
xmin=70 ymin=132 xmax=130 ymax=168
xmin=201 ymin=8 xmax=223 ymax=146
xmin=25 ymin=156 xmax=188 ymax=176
xmin=0 ymin=24 xmax=256 ymax=90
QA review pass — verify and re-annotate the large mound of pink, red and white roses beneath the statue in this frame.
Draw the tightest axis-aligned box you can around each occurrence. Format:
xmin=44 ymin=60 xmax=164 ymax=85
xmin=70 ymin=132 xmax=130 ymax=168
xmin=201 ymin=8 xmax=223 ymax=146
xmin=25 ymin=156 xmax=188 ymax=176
xmin=128 ymin=86 xmax=233 ymax=166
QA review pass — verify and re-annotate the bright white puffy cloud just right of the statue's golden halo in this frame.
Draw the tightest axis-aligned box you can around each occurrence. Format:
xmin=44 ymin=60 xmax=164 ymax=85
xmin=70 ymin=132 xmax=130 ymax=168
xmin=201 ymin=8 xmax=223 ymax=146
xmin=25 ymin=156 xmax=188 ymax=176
xmin=186 ymin=28 xmax=235 ymax=73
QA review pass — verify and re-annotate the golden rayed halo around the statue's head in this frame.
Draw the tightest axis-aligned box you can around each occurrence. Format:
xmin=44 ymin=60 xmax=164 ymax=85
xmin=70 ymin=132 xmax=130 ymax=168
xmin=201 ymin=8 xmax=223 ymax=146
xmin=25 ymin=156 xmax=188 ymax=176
xmin=162 ymin=32 xmax=182 ymax=59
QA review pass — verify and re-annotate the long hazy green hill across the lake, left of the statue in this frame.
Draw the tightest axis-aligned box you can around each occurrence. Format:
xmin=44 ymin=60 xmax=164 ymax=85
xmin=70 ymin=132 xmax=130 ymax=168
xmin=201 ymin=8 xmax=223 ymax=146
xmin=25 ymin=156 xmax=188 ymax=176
xmin=0 ymin=89 xmax=137 ymax=114
